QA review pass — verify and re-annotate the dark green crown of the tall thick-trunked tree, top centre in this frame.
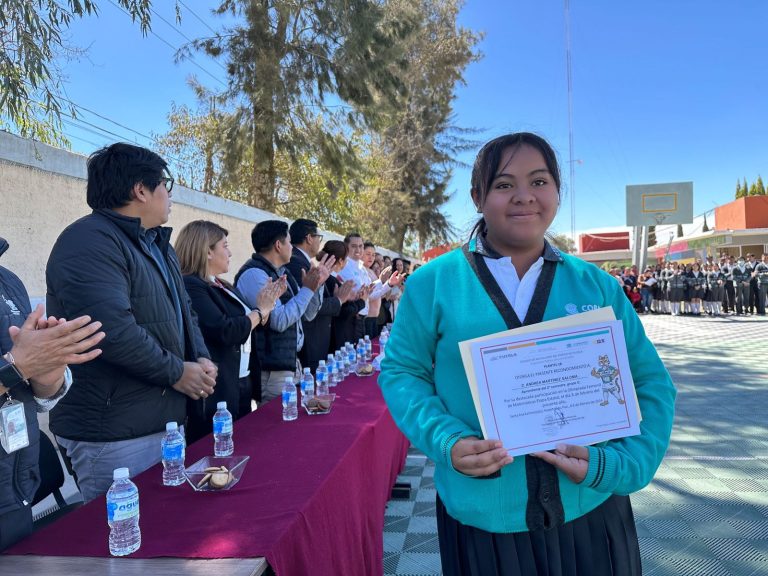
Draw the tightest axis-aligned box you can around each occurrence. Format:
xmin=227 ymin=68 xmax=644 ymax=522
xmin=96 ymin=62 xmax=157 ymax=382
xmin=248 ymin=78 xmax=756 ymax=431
xmin=179 ymin=0 xmax=413 ymax=210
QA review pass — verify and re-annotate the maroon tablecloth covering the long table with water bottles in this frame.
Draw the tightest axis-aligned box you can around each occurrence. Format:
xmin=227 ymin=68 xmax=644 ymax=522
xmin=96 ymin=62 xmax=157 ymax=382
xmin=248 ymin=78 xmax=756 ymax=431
xmin=7 ymin=377 xmax=408 ymax=576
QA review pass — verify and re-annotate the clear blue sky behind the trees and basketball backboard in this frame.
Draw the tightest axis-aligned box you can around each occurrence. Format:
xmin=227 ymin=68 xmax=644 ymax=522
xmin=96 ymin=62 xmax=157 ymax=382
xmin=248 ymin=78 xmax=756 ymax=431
xmin=55 ymin=0 xmax=768 ymax=242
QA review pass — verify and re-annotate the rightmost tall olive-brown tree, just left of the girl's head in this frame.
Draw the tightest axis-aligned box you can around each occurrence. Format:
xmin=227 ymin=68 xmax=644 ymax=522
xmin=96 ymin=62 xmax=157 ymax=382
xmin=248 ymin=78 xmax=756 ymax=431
xmin=360 ymin=0 xmax=480 ymax=252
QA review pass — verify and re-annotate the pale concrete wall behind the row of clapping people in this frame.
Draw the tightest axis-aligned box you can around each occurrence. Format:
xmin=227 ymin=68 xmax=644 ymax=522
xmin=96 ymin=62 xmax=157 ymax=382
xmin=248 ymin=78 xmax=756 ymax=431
xmin=0 ymin=131 xmax=396 ymax=301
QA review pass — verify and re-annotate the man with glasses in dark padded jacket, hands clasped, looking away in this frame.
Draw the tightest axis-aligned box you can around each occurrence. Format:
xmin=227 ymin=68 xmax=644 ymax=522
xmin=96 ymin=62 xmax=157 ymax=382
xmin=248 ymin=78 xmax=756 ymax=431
xmin=46 ymin=143 xmax=216 ymax=502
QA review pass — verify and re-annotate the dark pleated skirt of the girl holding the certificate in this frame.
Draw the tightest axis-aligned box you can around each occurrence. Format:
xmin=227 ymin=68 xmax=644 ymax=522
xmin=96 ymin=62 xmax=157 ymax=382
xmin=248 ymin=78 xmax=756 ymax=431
xmin=437 ymin=495 xmax=642 ymax=576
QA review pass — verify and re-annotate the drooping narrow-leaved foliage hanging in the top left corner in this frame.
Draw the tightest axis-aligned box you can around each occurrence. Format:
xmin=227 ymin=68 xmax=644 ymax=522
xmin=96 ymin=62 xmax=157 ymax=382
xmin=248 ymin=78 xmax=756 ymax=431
xmin=0 ymin=0 xmax=156 ymax=144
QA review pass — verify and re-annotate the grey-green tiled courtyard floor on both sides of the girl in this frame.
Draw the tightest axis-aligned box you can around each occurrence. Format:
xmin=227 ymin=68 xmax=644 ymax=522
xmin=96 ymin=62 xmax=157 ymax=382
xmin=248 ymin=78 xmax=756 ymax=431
xmin=384 ymin=315 xmax=768 ymax=576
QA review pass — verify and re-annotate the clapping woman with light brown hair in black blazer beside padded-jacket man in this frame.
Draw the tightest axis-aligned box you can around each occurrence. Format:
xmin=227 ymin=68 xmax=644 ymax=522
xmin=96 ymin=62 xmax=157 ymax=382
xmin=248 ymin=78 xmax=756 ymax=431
xmin=175 ymin=220 xmax=285 ymax=443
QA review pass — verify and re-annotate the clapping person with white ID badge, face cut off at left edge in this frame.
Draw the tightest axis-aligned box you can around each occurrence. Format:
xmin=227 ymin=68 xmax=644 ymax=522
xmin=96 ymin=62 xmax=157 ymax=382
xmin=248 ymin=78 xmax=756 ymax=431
xmin=0 ymin=238 xmax=104 ymax=551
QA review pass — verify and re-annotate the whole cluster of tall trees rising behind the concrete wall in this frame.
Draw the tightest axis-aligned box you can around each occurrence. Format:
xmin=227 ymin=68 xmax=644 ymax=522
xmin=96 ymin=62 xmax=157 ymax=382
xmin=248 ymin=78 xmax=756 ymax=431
xmin=158 ymin=0 xmax=478 ymax=253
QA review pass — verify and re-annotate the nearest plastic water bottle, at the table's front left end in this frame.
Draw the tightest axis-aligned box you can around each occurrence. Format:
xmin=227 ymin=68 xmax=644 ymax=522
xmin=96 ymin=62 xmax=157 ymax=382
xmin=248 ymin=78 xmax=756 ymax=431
xmin=107 ymin=468 xmax=141 ymax=556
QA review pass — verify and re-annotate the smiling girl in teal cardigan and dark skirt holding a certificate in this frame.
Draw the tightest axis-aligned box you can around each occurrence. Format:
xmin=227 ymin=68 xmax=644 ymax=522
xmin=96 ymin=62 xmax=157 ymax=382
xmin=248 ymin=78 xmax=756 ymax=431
xmin=379 ymin=133 xmax=675 ymax=576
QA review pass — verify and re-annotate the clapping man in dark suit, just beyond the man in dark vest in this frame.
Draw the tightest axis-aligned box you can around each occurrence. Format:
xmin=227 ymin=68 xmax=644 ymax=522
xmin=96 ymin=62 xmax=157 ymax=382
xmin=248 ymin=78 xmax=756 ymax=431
xmin=286 ymin=218 xmax=352 ymax=372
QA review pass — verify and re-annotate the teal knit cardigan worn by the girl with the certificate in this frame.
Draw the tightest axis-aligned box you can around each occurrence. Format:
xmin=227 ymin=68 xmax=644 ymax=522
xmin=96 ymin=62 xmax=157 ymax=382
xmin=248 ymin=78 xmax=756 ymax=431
xmin=379 ymin=245 xmax=676 ymax=532
